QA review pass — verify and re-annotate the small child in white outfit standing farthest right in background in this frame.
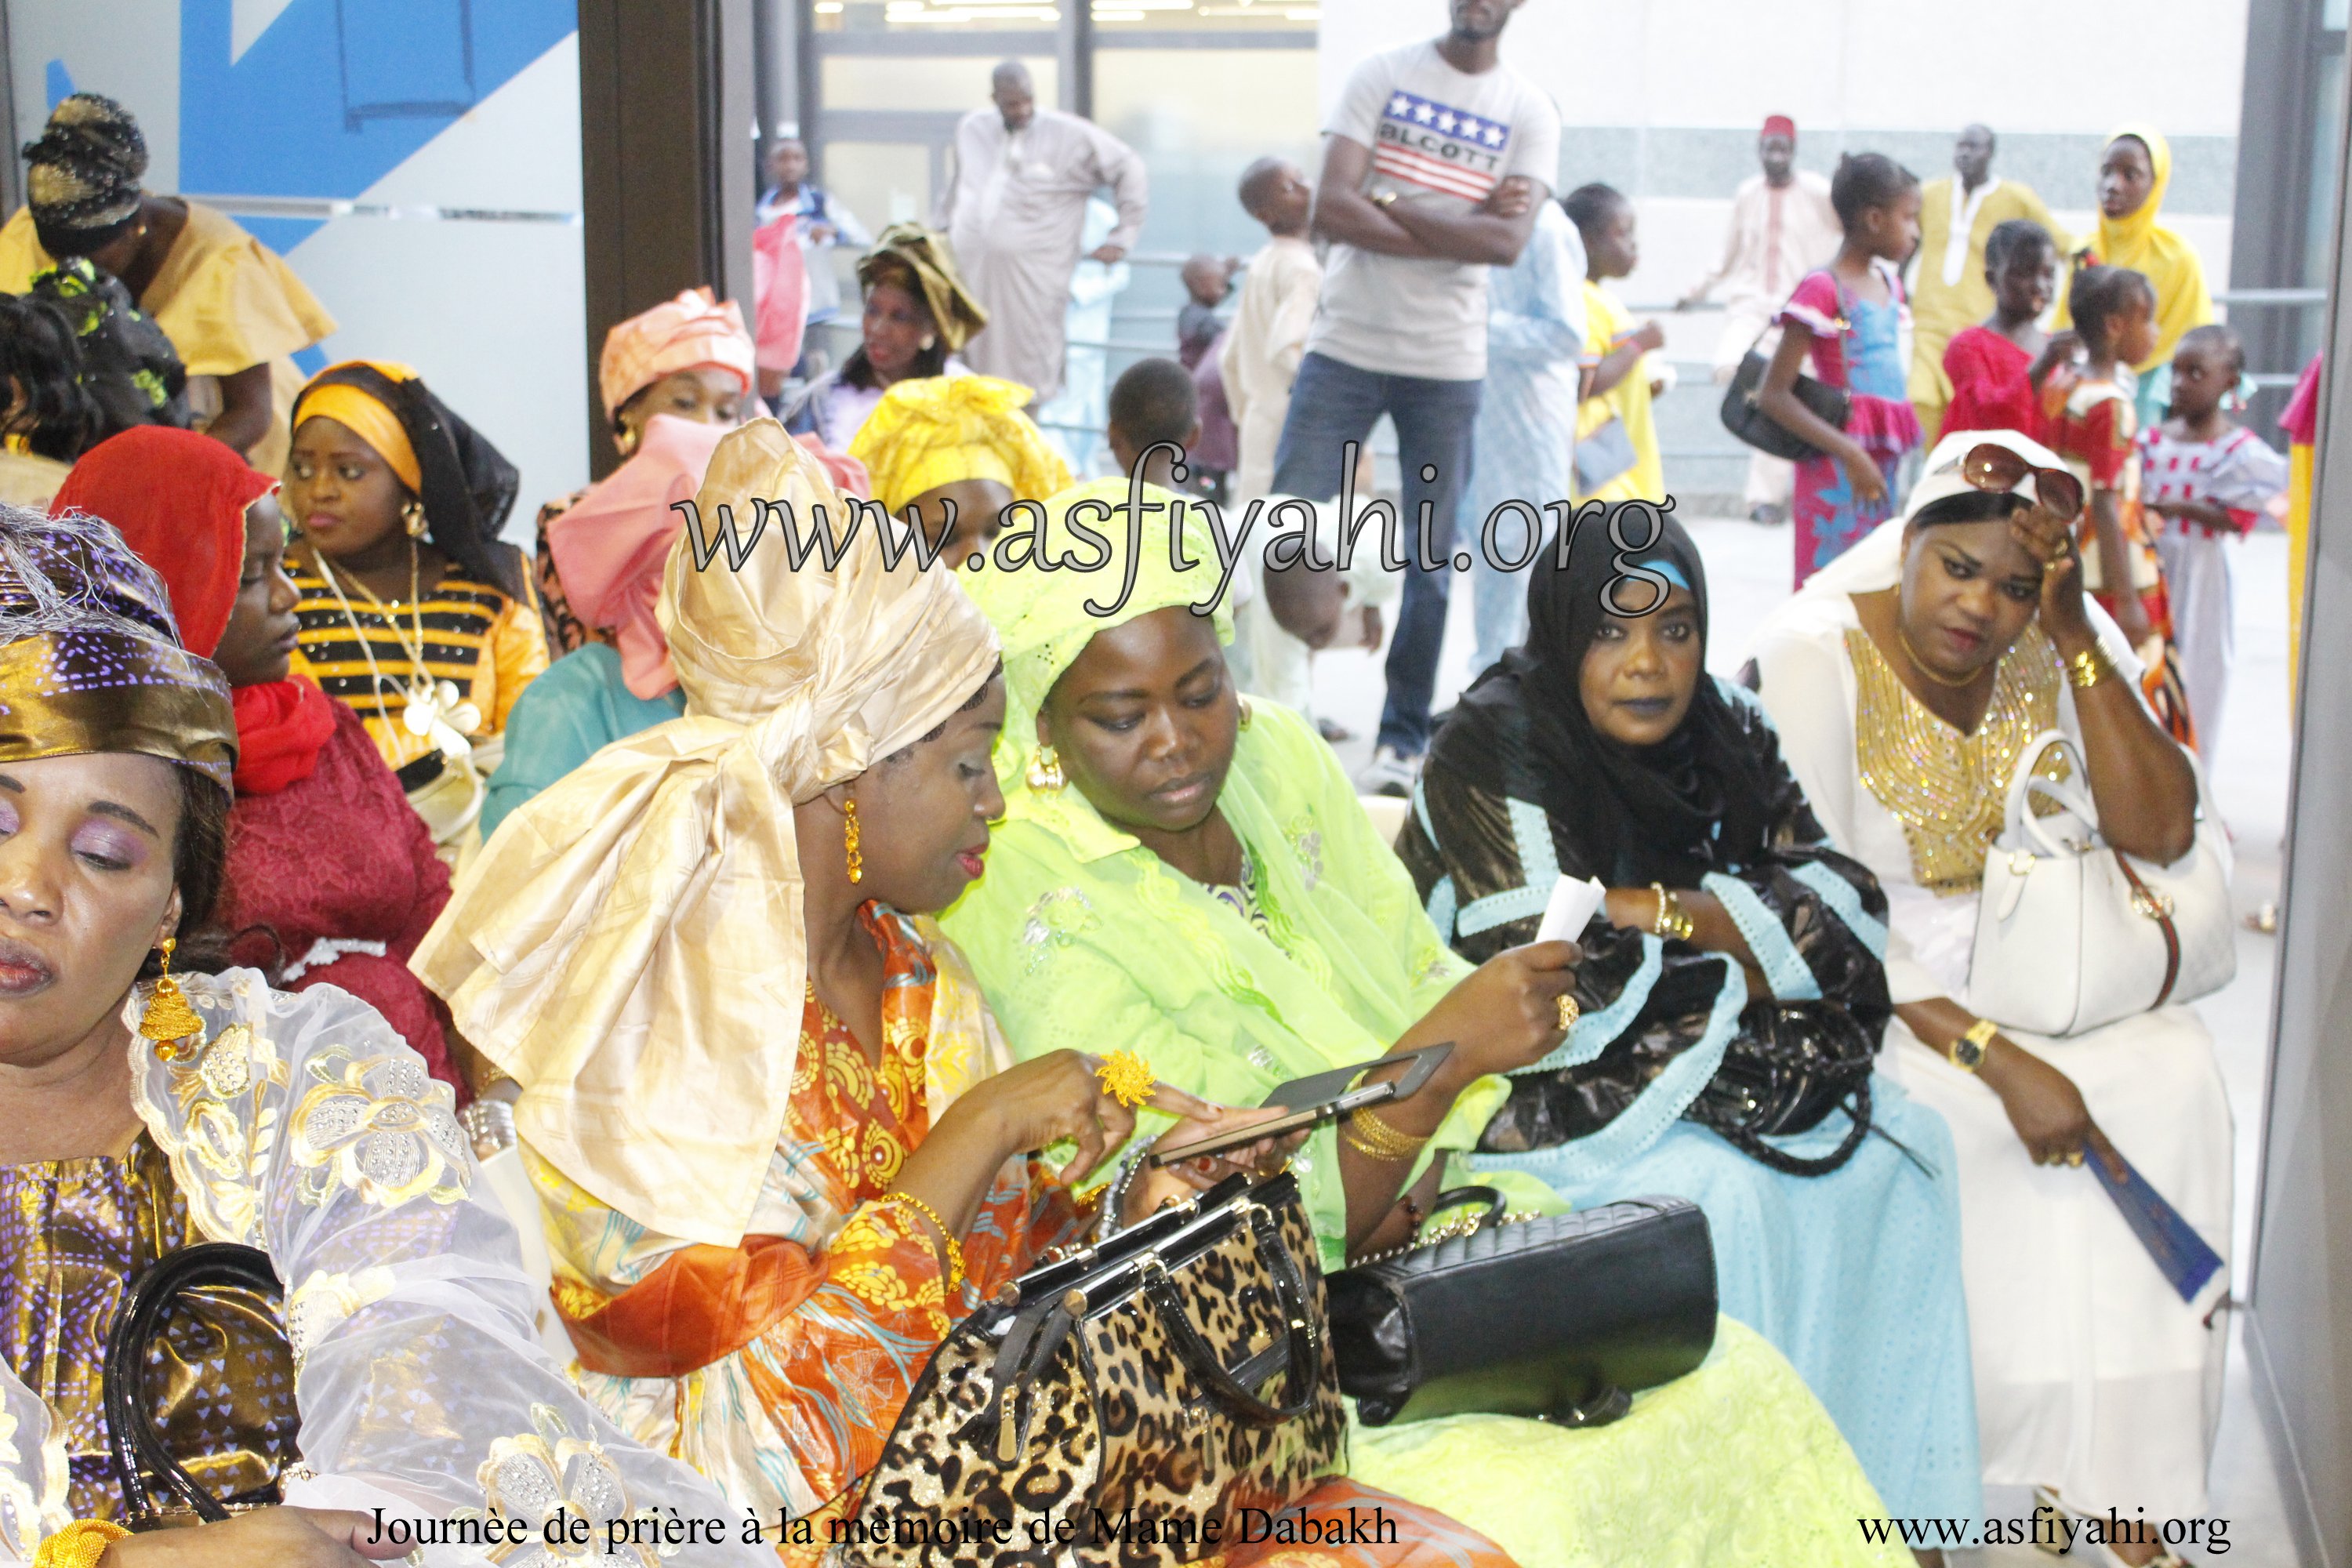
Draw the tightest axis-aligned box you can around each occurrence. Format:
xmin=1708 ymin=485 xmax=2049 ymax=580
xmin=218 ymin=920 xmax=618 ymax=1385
xmin=2140 ymin=325 xmax=2286 ymax=755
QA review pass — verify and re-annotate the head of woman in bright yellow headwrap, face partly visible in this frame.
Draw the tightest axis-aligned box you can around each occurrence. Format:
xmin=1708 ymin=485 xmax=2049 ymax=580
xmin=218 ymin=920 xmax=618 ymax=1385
xmin=849 ymin=376 xmax=1070 ymax=564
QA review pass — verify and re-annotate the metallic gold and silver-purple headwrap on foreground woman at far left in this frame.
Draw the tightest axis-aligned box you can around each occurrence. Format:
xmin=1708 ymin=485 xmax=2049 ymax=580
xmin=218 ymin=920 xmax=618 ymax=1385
xmin=0 ymin=508 xmax=234 ymax=789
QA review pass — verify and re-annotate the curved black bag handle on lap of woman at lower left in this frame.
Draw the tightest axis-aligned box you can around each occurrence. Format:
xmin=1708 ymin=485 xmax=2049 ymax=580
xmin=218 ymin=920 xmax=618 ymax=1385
xmin=106 ymin=1241 xmax=292 ymax=1530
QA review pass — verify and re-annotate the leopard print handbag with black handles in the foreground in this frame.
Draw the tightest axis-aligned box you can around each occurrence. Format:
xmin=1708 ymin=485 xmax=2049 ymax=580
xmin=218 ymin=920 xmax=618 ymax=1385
xmin=847 ymin=1173 xmax=1345 ymax=1568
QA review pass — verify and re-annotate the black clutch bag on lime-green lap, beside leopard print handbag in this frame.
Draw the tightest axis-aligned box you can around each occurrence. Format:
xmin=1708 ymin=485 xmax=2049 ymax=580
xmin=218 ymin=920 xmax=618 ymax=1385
xmin=1327 ymin=1187 xmax=1715 ymax=1427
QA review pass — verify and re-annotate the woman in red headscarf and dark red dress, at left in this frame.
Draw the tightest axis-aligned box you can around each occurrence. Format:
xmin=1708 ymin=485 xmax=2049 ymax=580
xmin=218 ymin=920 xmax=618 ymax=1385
xmin=49 ymin=426 xmax=466 ymax=1098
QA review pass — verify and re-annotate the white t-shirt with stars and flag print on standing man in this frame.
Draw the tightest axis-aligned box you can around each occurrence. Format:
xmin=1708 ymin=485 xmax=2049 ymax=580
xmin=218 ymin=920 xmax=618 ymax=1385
xmin=1308 ymin=42 xmax=1559 ymax=381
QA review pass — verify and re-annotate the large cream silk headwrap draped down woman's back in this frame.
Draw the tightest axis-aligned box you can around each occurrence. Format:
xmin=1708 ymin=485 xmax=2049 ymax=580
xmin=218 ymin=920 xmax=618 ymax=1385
xmin=412 ymin=419 xmax=997 ymax=1246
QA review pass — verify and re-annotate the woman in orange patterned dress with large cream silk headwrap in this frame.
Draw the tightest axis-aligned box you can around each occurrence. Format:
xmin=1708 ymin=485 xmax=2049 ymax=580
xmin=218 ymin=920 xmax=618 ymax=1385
xmin=416 ymin=421 xmax=1510 ymax=1568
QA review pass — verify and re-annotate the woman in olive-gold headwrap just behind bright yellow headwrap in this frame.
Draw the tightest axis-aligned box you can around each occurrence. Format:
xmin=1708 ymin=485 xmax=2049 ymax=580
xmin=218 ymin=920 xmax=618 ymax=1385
xmin=783 ymin=223 xmax=988 ymax=452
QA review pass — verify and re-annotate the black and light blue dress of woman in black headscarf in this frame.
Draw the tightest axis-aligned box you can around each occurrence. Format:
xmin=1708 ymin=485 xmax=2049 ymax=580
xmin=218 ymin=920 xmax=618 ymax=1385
xmin=1397 ymin=682 xmax=1985 ymax=1519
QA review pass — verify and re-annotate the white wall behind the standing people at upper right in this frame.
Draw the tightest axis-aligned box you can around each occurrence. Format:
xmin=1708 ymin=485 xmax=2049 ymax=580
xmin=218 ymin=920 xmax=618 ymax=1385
xmin=1319 ymin=0 xmax=2246 ymax=314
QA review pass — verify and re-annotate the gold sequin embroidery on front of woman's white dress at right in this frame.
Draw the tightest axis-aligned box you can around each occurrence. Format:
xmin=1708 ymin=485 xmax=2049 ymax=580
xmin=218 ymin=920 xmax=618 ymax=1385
xmin=1846 ymin=628 xmax=2067 ymax=898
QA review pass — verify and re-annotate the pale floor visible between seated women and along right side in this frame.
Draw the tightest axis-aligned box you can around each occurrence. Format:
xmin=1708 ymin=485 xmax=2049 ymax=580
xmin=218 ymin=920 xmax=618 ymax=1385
xmin=1315 ymin=520 xmax=2300 ymax=1568
